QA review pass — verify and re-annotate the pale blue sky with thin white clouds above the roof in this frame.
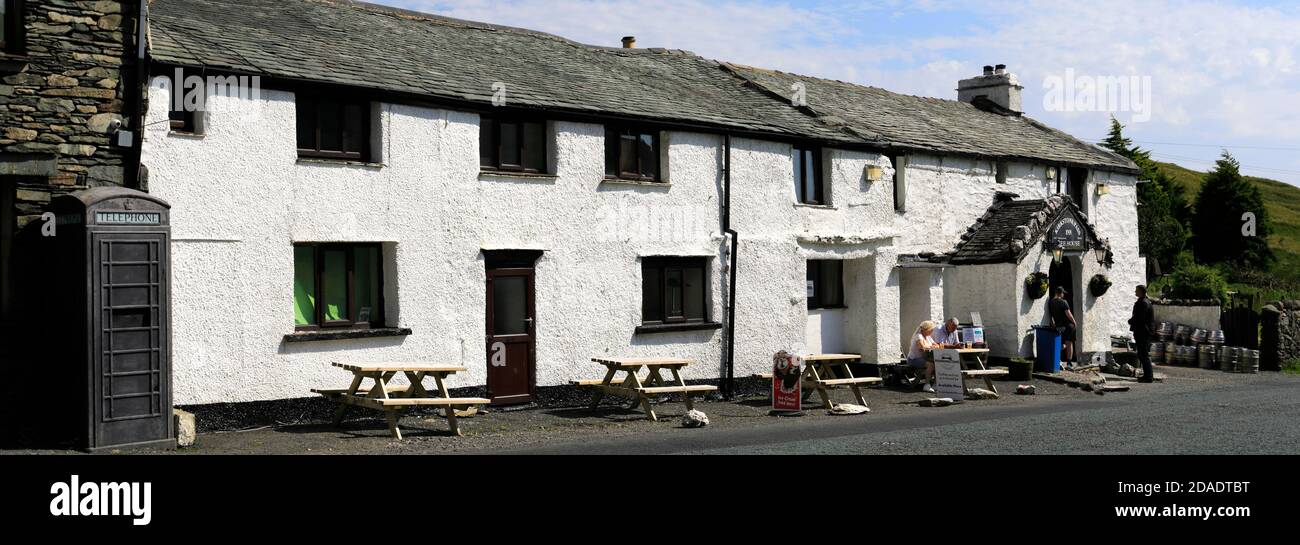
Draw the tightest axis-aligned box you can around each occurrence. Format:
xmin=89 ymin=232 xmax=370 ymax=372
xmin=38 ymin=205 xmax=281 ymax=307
xmin=371 ymin=0 xmax=1300 ymax=185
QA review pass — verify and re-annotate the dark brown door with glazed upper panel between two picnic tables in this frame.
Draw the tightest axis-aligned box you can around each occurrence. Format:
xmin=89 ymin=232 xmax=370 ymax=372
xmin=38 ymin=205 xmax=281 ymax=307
xmin=488 ymin=252 xmax=537 ymax=405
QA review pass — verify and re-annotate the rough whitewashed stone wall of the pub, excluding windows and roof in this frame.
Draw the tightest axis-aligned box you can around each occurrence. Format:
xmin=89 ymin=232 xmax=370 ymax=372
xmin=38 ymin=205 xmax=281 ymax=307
xmin=144 ymin=76 xmax=1141 ymax=405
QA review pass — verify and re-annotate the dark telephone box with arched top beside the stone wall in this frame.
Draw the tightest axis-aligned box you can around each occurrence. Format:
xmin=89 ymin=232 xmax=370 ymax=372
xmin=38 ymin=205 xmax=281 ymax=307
xmin=51 ymin=187 xmax=176 ymax=451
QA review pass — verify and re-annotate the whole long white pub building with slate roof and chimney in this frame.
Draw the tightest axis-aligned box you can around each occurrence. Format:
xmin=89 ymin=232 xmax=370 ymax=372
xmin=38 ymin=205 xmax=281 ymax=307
xmin=143 ymin=0 xmax=1145 ymax=406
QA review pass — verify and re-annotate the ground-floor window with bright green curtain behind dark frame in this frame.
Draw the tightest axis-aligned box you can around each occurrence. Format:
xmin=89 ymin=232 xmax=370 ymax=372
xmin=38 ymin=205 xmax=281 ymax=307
xmin=294 ymin=243 xmax=384 ymax=329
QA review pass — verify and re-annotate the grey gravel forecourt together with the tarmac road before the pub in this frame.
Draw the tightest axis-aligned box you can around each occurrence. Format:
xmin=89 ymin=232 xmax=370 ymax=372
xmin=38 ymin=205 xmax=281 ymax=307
xmin=9 ymin=367 xmax=1300 ymax=455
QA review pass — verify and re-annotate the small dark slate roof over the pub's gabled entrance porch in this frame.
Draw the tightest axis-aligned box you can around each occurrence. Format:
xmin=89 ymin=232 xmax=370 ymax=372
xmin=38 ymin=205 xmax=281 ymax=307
xmin=946 ymin=193 xmax=1100 ymax=265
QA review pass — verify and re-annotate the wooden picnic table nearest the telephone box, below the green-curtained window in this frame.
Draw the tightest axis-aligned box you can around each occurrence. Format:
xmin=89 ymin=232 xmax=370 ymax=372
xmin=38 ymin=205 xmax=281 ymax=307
xmin=312 ymin=362 xmax=491 ymax=440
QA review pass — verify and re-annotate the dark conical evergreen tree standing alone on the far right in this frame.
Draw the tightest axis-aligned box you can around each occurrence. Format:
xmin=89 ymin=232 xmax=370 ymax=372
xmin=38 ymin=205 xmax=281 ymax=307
xmin=1192 ymin=150 xmax=1277 ymax=271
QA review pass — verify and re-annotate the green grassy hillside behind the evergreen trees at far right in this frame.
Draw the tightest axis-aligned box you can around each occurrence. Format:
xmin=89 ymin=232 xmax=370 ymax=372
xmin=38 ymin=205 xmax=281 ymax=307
xmin=1160 ymin=163 xmax=1300 ymax=287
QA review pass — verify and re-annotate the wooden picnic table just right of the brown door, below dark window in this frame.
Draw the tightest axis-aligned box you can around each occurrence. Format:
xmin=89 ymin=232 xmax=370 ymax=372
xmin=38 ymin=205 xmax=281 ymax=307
xmin=571 ymin=358 xmax=718 ymax=421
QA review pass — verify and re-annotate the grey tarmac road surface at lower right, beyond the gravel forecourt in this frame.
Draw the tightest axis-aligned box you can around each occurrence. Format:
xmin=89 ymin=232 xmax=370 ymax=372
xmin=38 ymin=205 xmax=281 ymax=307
xmin=496 ymin=369 xmax=1300 ymax=454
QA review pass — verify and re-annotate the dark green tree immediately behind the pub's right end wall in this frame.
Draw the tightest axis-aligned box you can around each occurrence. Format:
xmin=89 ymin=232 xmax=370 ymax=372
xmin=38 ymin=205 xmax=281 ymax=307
xmin=1101 ymin=117 xmax=1188 ymax=271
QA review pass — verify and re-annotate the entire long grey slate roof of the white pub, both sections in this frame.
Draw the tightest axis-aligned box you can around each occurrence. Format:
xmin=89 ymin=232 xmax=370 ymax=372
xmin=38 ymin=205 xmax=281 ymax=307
xmin=150 ymin=0 xmax=1136 ymax=172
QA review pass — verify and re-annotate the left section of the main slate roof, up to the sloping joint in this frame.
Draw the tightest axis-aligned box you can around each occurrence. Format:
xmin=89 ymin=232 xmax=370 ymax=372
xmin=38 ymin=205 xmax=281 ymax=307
xmin=150 ymin=0 xmax=857 ymax=142
